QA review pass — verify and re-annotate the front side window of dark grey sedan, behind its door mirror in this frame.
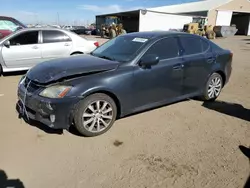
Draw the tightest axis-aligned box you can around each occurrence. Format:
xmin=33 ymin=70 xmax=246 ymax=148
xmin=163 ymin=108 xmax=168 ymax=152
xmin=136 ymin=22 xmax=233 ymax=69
xmin=145 ymin=38 xmax=179 ymax=60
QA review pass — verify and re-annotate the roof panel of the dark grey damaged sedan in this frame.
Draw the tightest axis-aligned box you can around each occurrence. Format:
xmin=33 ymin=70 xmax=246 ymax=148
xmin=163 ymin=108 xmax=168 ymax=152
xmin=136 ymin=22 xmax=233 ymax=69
xmin=127 ymin=31 xmax=194 ymax=39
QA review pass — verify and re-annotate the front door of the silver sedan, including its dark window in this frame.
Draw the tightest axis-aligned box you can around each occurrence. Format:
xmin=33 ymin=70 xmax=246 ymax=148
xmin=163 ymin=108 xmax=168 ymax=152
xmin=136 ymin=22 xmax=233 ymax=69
xmin=2 ymin=31 xmax=42 ymax=68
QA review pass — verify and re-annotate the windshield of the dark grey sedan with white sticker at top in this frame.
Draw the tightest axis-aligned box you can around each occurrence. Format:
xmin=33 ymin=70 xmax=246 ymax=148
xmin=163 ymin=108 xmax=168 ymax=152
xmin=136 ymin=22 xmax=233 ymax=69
xmin=91 ymin=35 xmax=149 ymax=62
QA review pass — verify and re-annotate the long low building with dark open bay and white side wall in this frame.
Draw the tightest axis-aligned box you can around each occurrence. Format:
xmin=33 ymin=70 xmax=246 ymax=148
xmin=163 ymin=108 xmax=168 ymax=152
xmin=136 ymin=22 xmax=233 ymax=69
xmin=96 ymin=10 xmax=193 ymax=33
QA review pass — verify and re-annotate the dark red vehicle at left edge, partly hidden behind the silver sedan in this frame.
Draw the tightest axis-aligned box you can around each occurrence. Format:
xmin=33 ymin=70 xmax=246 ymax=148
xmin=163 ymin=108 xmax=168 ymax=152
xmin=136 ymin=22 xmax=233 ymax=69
xmin=0 ymin=16 xmax=27 ymax=39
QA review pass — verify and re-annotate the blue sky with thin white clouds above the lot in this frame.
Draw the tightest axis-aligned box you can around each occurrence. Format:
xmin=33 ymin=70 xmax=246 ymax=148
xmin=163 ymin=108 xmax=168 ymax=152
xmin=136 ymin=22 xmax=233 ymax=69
xmin=0 ymin=0 xmax=197 ymax=24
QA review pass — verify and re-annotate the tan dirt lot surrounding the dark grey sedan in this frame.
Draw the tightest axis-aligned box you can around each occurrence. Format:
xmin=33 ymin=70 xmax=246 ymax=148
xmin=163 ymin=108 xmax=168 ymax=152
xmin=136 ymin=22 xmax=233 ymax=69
xmin=0 ymin=37 xmax=250 ymax=188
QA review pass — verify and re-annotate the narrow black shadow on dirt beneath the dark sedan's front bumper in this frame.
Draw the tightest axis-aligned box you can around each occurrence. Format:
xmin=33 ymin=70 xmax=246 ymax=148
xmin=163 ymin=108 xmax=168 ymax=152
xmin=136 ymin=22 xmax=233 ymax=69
xmin=16 ymin=104 xmax=63 ymax=135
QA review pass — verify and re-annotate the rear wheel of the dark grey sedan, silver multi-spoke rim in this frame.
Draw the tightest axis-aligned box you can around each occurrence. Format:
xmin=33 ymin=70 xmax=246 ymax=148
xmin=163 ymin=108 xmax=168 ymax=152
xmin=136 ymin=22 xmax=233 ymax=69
xmin=202 ymin=73 xmax=223 ymax=101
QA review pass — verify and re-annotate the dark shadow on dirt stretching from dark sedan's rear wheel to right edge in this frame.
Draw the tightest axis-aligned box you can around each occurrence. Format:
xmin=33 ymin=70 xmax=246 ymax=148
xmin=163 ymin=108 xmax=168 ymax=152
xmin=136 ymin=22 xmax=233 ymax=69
xmin=202 ymin=101 xmax=250 ymax=121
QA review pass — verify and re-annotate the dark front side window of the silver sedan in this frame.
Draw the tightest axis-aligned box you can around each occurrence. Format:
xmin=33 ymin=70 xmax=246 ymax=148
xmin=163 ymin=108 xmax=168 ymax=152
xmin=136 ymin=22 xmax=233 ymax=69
xmin=10 ymin=31 xmax=38 ymax=46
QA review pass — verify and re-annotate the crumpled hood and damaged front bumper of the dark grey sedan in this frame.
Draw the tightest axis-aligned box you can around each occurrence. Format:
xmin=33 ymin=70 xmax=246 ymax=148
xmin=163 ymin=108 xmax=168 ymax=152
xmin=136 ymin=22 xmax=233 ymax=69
xmin=18 ymin=55 xmax=119 ymax=129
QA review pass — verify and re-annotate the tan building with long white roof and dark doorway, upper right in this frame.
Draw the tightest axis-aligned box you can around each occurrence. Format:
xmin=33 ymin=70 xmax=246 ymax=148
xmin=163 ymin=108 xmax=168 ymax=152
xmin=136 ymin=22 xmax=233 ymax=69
xmin=149 ymin=0 xmax=250 ymax=35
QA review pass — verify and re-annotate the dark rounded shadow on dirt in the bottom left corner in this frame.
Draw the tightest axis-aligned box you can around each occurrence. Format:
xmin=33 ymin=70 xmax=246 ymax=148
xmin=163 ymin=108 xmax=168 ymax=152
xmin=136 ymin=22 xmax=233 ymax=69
xmin=0 ymin=169 xmax=25 ymax=188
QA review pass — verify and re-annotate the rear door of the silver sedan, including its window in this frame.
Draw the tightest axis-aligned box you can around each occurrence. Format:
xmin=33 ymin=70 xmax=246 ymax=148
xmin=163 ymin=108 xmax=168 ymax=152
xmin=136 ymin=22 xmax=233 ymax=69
xmin=42 ymin=30 xmax=73 ymax=60
